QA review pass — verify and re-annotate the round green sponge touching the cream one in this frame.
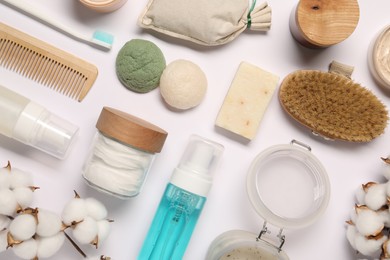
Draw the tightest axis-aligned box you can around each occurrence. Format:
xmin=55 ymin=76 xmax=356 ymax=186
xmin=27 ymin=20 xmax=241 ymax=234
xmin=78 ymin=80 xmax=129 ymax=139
xmin=115 ymin=39 xmax=166 ymax=93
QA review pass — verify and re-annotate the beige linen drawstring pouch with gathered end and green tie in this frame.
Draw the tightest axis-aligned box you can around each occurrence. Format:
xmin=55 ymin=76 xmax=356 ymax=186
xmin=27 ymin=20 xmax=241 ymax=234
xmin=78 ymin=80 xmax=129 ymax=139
xmin=138 ymin=0 xmax=271 ymax=46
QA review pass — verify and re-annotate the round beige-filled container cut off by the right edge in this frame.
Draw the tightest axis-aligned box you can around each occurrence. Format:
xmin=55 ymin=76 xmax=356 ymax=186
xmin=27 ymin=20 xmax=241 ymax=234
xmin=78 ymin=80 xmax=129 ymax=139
xmin=368 ymin=25 xmax=390 ymax=90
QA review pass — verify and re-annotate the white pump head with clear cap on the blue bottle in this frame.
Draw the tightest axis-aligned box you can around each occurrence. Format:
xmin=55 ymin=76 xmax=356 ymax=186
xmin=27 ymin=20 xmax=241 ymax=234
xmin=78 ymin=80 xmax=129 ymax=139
xmin=171 ymin=135 xmax=224 ymax=197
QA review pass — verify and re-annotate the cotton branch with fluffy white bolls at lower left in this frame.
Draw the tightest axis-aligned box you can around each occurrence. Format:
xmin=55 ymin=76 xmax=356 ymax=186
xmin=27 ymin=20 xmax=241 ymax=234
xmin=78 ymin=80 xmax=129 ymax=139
xmin=0 ymin=162 xmax=112 ymax=260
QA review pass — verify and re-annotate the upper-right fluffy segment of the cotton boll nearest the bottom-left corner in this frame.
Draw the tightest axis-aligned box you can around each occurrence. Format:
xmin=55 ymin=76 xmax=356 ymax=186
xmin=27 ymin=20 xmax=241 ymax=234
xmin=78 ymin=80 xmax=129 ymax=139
xmin=36 ymin=209 xmax=62 ymax=237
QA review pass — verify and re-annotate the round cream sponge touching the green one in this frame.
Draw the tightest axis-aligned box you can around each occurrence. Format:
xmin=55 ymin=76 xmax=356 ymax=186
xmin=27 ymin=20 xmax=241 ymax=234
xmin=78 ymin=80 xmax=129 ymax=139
xmin=160 ymin=60 xmax=207 ymax=110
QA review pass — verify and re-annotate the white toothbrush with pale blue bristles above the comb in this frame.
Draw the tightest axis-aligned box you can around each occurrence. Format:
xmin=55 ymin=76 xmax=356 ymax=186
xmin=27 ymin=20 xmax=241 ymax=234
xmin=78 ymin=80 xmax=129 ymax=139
xmin=0 ymin=0 xmax=114 ymax=50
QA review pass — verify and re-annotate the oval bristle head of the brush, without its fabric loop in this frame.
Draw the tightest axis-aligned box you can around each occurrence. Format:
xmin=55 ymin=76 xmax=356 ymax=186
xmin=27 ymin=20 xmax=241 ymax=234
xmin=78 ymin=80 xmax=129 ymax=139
xmin=279 ymin=71 xmax=388 ymax=142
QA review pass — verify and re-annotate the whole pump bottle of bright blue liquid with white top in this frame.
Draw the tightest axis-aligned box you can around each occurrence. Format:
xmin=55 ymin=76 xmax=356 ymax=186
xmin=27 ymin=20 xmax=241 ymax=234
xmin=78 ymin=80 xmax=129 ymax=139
xmin=138 ymin=135 xmax=224 ymax=260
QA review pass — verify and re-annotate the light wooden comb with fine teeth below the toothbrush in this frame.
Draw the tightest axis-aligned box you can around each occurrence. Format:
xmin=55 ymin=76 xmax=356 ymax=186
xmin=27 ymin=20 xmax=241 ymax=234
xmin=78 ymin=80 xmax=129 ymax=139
xmin=0 ymin=23 xmax=98 ymax=102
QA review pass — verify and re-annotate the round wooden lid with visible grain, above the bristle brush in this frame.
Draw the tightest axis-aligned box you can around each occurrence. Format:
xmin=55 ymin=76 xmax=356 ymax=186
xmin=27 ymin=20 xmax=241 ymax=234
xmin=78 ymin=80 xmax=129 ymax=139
xmin=290 ymin=0 xmax=360 ymax=47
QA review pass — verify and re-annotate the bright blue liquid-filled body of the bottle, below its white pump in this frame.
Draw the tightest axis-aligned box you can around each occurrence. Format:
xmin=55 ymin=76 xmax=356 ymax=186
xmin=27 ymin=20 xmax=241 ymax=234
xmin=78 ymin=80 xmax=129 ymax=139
xmin=138 ymin=184 xmax=206 ymax=260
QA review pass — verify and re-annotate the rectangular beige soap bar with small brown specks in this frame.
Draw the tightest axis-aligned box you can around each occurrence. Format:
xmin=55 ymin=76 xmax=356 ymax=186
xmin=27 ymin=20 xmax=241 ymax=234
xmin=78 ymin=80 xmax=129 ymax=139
xmin=215 ymin=62 xmax=279 ymax=140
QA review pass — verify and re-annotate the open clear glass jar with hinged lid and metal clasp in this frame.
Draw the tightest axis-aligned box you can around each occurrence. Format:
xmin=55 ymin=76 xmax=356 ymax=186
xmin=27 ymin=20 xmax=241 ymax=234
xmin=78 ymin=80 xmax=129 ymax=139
xmin=206 ymin=140 xmax=330 ymax=260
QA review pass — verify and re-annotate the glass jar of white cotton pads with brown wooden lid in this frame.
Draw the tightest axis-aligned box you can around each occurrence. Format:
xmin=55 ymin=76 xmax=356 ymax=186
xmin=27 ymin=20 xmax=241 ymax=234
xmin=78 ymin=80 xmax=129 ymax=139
xmin=82 ymin=107 xmax=168 ymax=199
